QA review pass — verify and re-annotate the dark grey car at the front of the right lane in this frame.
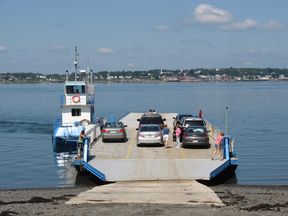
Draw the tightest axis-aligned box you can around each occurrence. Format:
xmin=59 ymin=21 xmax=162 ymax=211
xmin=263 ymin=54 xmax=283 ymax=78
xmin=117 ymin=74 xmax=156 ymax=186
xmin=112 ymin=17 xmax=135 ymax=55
xmin=182 ymin=126 xmax=209 ymax=147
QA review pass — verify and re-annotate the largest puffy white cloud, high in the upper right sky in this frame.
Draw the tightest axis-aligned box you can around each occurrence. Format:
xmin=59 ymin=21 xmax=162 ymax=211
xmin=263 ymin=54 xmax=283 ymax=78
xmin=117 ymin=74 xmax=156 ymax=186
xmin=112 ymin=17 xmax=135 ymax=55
xmin=193 ymin=4 xmax=234 ymax=24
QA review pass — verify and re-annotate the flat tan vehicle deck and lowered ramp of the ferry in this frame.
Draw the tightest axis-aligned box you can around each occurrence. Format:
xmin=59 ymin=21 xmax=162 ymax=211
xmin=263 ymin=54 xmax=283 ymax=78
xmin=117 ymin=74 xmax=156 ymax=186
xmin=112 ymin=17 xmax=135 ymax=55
xmin=88 ymin=113 xmax=226 ymax=181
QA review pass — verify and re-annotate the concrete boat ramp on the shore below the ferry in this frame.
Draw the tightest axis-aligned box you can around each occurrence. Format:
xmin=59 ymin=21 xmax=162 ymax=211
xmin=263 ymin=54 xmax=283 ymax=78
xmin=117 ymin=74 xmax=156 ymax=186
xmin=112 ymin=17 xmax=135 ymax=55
xmin=66 ymin=180 xmax=224 ymax=206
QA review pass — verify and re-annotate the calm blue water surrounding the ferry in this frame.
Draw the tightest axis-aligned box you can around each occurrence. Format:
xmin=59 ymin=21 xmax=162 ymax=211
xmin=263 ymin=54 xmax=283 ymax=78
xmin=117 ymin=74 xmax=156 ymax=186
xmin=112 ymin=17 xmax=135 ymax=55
xmin=0 ymin=82 xmax=288 ymax=189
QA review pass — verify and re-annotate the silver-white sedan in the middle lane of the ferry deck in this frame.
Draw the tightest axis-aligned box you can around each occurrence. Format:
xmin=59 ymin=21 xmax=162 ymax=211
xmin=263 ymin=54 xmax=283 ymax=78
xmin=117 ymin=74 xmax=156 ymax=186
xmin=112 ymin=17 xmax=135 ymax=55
xmin=137 ymin=124 xmax=163 ymax=146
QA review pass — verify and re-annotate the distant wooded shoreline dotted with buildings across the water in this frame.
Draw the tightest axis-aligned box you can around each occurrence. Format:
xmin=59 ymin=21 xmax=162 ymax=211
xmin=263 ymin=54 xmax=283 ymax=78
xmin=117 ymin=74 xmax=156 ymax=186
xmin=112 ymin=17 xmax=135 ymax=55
xmin=0 ymin=67 xmax=288 ymax=82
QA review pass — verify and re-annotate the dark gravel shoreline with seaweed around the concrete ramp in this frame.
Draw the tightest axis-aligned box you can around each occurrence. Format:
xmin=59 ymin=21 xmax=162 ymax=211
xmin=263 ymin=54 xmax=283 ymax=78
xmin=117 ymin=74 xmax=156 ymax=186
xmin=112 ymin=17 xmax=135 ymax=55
xmin=0 ymin=184 xmax=288 ymax=216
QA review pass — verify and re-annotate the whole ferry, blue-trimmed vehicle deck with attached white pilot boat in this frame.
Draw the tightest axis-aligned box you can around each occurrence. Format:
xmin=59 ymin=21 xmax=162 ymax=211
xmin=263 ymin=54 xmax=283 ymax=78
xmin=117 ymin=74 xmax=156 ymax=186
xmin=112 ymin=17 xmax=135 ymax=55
xmin=53 ymin=48 xmax=238 ymax=182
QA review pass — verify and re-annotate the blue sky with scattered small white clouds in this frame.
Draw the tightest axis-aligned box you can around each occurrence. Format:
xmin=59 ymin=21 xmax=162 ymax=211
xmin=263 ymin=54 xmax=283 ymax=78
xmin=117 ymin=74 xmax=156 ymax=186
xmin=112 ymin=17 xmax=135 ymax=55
xmin=0 ymin=0 xmax=288 ymax=74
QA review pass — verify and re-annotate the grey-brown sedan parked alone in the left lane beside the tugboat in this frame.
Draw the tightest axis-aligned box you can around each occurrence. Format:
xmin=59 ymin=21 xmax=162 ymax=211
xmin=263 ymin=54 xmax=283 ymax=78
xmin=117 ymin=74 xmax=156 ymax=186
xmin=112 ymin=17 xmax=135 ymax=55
xmin=102 ymin=121 xmax=127 ymax=142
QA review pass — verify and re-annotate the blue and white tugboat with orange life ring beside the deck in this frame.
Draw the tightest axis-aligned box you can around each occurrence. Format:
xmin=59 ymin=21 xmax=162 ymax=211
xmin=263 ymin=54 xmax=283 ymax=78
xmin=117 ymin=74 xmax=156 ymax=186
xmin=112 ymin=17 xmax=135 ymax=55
xmin=52 ymin=47 xmax=100 ymax=147
